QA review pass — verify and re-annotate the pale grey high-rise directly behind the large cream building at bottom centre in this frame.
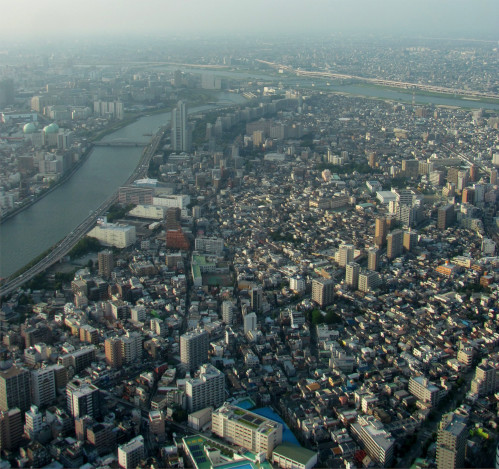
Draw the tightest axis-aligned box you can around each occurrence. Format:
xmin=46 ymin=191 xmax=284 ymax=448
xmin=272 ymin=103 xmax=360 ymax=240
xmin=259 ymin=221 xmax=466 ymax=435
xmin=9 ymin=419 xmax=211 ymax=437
xmin=185 ymin=363 xmax=225 ymax=412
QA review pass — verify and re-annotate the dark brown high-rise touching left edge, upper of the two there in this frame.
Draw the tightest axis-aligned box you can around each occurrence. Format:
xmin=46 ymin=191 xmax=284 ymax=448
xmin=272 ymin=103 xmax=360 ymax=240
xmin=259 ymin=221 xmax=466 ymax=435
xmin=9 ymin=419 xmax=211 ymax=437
xmin=0 ymin=366 xmax=31 ymax=412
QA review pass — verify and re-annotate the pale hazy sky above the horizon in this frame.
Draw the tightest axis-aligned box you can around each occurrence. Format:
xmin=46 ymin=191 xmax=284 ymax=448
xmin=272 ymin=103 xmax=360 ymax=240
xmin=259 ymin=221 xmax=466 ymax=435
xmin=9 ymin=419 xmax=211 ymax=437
xmin=0 ymin=0 xmax=499 ymax=40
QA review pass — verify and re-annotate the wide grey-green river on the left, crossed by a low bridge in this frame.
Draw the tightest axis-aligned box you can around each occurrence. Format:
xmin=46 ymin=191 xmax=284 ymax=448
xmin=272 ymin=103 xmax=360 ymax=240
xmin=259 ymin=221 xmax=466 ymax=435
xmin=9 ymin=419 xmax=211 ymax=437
xmin=0 ymin=93 xmax=245 ymax=277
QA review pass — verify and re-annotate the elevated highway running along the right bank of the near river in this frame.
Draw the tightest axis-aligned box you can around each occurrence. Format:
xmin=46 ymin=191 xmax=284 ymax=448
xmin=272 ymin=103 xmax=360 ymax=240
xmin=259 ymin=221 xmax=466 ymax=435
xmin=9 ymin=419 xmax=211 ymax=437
xmin=0 ymin=126 xmax=167 ymax=298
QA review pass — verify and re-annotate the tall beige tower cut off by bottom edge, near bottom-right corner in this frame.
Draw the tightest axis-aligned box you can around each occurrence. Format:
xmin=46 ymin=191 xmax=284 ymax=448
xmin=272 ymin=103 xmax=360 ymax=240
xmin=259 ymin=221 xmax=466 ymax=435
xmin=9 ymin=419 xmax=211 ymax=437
xmin=437 ymin=413 xmax=468 ymax=469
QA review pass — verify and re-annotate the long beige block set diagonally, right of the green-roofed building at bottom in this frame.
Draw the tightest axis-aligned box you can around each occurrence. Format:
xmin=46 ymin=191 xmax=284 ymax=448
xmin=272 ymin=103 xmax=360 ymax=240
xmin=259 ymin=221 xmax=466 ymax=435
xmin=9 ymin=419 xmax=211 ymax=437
xmin=350 ymin=415 xmax=395 ymax=467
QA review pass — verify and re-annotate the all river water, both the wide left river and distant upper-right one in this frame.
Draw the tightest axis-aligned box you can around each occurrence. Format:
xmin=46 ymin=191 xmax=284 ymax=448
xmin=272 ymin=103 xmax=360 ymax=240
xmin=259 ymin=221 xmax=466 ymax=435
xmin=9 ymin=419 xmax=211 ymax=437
xmin=0 ymin=81 xmax=499 ymax=277
